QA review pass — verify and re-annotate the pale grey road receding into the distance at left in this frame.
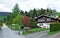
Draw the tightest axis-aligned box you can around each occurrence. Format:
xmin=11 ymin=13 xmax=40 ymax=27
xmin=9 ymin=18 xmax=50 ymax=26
xmin=0 ymin=25 xmax=25 ymax=38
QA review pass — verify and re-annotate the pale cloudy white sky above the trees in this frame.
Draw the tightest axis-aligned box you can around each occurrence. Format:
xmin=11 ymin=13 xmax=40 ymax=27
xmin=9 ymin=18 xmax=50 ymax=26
xmin=0 ymin=0 xmax=60 ymax=12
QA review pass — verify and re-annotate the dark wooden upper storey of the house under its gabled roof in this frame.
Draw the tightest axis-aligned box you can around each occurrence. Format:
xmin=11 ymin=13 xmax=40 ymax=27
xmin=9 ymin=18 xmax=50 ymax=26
xmin=36 ymin=16 xmax=60 ymax=23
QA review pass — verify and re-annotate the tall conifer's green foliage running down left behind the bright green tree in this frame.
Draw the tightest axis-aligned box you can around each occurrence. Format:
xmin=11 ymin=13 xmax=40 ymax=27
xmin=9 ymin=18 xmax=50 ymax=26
xmin=6 ymin=4 xmax=20 ymax=24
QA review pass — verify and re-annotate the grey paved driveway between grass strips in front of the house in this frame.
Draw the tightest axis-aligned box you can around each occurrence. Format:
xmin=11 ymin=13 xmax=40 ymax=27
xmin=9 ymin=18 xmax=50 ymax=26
xmin=25 ymin=30 xmax=49 ymax=38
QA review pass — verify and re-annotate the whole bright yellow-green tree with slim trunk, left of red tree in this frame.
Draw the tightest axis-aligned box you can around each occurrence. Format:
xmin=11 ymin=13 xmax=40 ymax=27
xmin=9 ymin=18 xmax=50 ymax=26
xmin=13 ymin=14 xmax=24 ymax=34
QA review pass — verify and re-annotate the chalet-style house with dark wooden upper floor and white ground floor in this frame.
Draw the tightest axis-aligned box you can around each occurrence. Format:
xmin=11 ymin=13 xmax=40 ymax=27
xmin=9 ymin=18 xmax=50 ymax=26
xmin=35 ymin=15 xmax=60 ymax=28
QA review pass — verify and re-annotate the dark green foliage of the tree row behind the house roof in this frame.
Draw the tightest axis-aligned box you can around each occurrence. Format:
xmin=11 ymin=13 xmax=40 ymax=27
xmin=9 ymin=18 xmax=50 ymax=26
xmin=25 ymin=8 xmax=57 ymax=18
